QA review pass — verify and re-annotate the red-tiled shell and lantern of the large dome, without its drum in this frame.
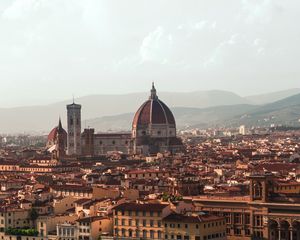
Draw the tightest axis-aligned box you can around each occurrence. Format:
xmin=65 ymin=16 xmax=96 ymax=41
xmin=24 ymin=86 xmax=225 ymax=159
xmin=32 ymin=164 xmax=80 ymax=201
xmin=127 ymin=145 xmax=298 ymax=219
xmin=132 ymin=85 xmax=175 ymax=128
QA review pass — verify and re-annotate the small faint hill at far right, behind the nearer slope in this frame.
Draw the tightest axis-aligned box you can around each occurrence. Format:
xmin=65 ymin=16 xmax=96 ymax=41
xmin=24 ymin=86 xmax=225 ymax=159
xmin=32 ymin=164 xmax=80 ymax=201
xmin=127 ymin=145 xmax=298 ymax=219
xmin=245 ymin=88 xmax=300 ymax=105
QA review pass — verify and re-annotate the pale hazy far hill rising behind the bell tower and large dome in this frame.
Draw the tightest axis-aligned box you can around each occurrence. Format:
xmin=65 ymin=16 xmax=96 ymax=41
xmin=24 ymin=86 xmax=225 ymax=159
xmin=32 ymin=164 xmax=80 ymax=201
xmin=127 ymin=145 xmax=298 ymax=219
xmin=0 ymin=90 xmax=248 ymax=133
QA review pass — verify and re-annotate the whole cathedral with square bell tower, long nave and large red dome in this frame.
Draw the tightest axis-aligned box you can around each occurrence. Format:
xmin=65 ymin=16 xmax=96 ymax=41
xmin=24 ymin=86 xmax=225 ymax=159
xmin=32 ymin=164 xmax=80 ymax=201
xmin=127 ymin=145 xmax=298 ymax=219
xmin=48 ymin=84 xmax=183 ymax=156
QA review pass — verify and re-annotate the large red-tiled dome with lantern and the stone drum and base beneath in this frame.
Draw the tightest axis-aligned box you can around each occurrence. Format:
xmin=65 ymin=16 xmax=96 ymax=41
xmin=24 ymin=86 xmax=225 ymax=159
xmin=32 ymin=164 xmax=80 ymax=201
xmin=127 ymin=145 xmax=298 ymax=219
xmin=132 ymin=84 xmax=183 ymax=154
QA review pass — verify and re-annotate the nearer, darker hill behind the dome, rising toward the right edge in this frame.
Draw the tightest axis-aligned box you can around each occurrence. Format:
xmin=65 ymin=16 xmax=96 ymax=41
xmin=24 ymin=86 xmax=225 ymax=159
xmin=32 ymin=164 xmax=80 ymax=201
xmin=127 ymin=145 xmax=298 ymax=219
xmin=86 ymin=94 xmax=300 ymax=131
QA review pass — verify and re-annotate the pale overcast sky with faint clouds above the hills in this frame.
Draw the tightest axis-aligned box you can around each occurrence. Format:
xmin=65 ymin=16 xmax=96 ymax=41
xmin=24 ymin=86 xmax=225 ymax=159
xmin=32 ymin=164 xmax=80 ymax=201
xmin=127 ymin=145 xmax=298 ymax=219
xmin=0 ymin=0 xmax=300 ymax=107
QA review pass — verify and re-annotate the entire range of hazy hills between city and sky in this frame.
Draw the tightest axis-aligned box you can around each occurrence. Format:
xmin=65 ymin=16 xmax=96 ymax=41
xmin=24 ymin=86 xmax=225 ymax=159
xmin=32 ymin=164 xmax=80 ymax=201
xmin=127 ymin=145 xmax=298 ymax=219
xmin=0 ymin=90 xmax=300 ymax=133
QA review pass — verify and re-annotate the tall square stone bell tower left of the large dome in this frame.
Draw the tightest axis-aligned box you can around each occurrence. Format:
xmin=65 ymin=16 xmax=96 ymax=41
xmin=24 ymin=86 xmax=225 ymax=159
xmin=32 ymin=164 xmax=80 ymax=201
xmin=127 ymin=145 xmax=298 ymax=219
xmin=67 ymin=102 xmax=81 ymax=155
